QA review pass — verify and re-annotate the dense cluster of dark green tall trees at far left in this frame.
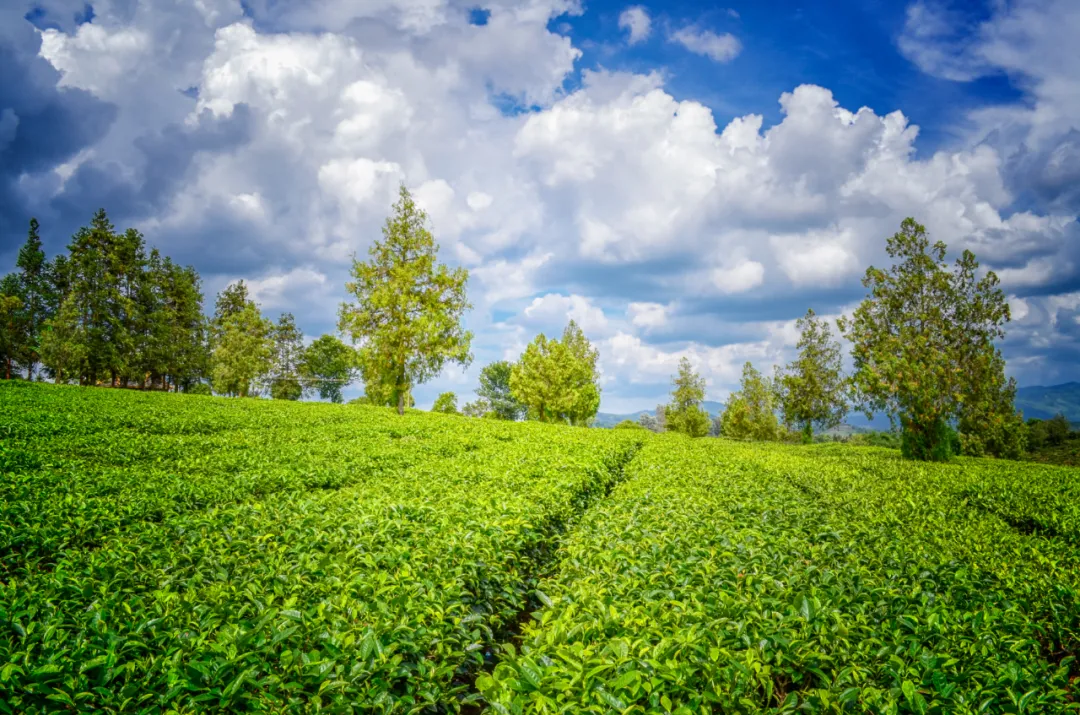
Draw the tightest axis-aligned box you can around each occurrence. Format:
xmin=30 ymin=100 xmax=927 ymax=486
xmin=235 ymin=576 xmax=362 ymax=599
xmin=0 ymin=210 xmax=207 ymax=390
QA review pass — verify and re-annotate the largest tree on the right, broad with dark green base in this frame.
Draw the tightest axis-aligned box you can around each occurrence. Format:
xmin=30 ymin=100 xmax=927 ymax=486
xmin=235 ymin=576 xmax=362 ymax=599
xmin=840 ymin=218 xmax=1012 ymax=461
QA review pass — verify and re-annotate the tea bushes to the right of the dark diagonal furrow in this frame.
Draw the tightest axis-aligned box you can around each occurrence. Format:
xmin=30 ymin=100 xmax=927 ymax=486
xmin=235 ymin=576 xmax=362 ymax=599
xmin=476 ymin=437 xmax=1080 ymax=715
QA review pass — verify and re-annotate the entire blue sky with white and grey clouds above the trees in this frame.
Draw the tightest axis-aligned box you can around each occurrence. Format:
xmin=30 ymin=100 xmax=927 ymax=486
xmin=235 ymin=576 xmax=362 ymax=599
xmin=0 ymin=0 xmax=1080 ymax=413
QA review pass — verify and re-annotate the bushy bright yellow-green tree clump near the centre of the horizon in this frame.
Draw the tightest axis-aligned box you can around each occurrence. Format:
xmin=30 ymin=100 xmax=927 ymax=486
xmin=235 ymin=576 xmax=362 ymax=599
xmin=510 ymin=320 xmax=600 ymax=426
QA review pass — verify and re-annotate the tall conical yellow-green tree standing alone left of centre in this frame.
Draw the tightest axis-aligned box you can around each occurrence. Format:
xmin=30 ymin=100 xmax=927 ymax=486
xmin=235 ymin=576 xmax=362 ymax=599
xmin=338 ymin=185 xmax=472 ymax=415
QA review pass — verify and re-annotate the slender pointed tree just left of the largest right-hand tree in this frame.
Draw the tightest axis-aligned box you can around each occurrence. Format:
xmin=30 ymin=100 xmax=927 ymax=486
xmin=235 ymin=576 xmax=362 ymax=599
xmin=774 ymin=309 xmax=848 ymax=443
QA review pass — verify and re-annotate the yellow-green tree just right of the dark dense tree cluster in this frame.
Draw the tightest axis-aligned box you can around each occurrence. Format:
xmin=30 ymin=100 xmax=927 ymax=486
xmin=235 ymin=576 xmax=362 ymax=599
xmin=211 ymin=286 xmax=273 ymax=397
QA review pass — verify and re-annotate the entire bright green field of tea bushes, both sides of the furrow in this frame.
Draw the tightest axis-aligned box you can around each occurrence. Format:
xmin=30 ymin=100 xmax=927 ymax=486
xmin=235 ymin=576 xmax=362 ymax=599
xmin=0 ymin=383 xmax=1080 ymax=715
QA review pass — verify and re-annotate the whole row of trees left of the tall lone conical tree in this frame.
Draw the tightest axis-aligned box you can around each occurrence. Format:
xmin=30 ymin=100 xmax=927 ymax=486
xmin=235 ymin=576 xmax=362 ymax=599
xmin=0 ymin=210 xmax=357 ymax=402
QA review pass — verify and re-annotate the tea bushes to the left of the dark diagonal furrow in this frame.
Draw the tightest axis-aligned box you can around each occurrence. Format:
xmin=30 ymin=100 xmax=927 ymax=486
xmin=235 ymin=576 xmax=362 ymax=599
xmin=0 ymin=383 xmax=639 ymax=715
